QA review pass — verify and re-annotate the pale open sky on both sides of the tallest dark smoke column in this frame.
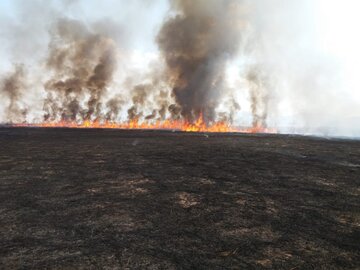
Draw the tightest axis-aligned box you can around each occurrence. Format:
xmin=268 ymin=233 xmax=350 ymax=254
xmin=0 ymin=0 xmax=360 ymax=136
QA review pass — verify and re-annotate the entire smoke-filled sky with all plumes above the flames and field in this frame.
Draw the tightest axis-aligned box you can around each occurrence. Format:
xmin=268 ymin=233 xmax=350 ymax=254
xmin=0 ymin=0 xmax=360 ymax=135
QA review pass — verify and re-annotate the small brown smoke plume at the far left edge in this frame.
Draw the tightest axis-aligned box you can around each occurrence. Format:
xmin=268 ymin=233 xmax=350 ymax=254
xmin=0 ymin=65 xmax=26 ymax=122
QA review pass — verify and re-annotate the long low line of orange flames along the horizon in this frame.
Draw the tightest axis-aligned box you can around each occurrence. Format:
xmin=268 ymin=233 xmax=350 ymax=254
xmin=16 ymin=115 xmax=276 ymax=133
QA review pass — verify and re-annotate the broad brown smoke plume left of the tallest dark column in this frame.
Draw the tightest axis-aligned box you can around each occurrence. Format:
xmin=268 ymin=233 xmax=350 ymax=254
xmin=44 ymin=19 xmax=116 ymax=121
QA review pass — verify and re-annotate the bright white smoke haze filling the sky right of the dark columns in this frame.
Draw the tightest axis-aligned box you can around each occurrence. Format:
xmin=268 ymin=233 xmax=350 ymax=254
xmin=225 ymin=0 xmax=360 ymax=136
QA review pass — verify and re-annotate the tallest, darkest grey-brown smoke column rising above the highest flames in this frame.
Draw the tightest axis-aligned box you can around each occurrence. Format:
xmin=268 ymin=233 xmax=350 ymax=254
xmin=157 ymin=0 xmax=243 ymax=121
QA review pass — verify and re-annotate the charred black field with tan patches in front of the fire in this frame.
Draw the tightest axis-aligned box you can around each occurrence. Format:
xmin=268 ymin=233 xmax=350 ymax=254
xmin=0 ymin=128 xmax=360 ymax=269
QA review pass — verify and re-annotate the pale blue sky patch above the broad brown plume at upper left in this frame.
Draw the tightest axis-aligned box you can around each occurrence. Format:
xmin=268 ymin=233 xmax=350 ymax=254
xmin=0 ymin=0 xmax=169 ymax=63
